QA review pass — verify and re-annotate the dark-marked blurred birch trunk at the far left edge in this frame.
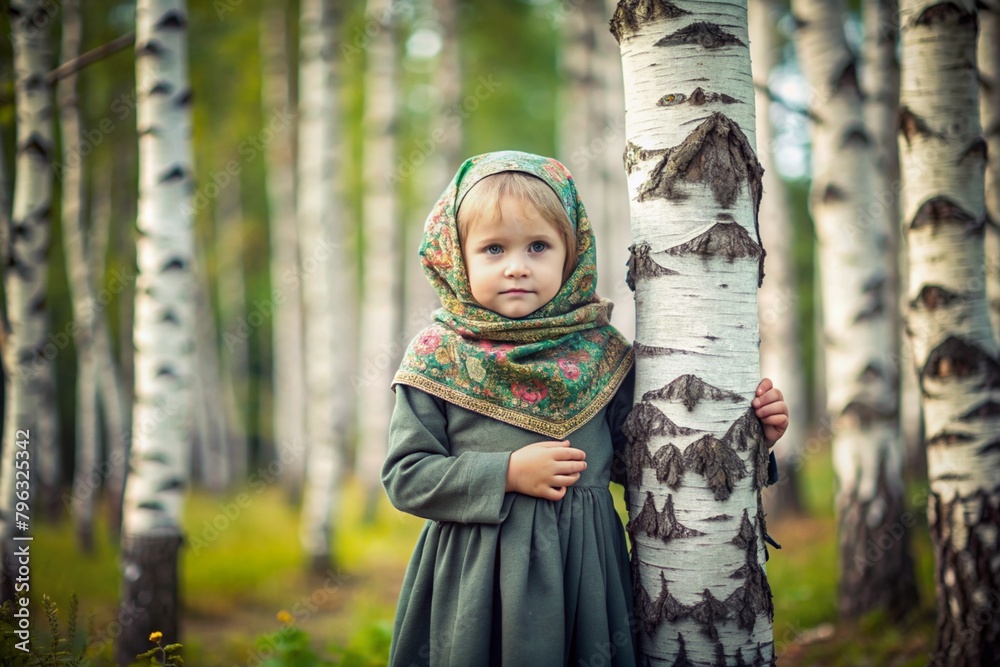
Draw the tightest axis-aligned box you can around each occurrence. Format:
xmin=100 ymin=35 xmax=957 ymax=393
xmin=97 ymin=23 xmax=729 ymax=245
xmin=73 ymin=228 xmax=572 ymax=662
xmin=0 ymin=0 xmax=59 ymax=599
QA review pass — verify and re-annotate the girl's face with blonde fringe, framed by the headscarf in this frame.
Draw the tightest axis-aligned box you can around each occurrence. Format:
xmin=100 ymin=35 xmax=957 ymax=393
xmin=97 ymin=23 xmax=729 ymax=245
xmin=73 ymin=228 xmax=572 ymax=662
xmin=462 ymin=197 xmax=566 ymax=319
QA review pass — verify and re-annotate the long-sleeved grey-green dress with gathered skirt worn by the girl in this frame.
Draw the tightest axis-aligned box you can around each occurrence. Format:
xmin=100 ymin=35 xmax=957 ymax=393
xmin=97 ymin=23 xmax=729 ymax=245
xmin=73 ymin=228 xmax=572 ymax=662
xmin=382 ymin=370 xmax=637 ymax=667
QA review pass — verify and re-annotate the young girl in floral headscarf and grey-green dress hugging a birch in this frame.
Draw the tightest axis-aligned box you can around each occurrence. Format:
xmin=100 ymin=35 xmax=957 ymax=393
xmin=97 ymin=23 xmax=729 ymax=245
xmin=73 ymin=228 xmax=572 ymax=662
xmin=382 ymin=151 xmax=788 ymax=667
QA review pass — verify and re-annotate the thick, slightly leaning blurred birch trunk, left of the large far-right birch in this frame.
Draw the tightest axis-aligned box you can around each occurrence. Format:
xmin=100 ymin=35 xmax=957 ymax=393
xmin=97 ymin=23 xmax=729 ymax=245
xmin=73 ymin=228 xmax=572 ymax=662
xmin=792 ymin=0 xmax=916 ymax=617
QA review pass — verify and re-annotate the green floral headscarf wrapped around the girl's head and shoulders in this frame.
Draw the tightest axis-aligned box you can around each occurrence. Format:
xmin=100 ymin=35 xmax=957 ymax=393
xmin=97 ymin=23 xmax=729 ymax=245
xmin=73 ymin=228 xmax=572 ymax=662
xmin=392 ymin=151 xmax=632 ymax=439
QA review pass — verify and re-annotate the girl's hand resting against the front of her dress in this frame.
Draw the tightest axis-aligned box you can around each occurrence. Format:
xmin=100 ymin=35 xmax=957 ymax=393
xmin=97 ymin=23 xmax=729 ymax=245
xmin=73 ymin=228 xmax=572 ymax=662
xmin=507 ymin=440 xmax=587 ymax=500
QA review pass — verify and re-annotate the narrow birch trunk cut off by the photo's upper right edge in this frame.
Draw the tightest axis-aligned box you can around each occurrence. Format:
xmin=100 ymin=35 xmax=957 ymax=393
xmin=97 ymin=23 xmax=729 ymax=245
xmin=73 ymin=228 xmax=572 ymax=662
xmin=977 ymin=0 xmax=1000 ymax=336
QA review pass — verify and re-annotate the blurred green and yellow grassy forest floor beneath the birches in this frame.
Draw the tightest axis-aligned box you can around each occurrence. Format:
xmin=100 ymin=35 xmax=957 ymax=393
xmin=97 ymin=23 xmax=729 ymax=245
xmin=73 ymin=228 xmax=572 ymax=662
xmin=32 ymin=440 xmax=934 ymax=667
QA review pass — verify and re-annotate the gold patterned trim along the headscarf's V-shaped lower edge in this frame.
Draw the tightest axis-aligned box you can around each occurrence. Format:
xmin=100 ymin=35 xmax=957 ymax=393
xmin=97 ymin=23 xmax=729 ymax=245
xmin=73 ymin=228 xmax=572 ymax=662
xmin=391 ymin=347 xmax=634 ymax=440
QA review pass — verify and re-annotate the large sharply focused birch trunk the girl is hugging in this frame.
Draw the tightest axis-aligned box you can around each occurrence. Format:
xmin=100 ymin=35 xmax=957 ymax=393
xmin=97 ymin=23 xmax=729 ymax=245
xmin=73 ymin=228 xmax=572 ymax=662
xmin=611 ymin=0 xmax=774 ymax=665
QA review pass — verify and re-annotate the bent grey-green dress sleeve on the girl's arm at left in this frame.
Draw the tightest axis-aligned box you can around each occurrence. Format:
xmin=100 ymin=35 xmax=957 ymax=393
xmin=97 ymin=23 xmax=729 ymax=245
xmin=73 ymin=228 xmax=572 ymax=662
xmin=382 ymin=385 xmax=513 ymax=524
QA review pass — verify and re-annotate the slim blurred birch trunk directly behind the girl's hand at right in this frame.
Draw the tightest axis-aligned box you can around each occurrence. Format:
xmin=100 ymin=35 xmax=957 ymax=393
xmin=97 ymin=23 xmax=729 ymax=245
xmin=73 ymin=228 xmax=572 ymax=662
xmin=749 ymin=0 xmax=809 ymax=517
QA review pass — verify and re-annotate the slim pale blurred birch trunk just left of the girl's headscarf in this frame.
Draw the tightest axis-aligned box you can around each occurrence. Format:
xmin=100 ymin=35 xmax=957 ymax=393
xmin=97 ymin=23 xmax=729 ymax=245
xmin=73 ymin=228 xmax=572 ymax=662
xmin=358 ymin=0 xmax=403 ymax=521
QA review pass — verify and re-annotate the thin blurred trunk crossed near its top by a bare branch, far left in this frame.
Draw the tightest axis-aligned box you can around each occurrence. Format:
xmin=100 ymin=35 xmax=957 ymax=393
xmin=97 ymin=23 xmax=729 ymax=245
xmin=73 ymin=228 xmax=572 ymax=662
xmin=56 ymin=0 xmax=99 ymax=553
